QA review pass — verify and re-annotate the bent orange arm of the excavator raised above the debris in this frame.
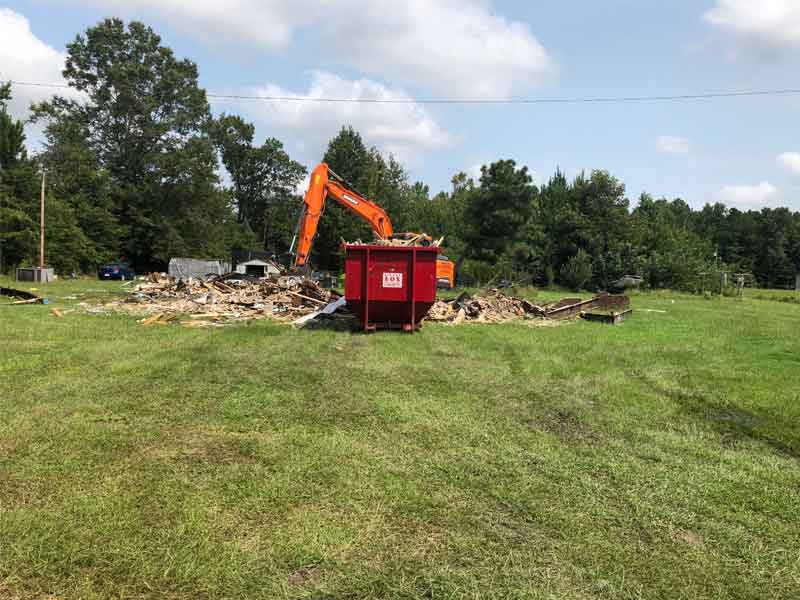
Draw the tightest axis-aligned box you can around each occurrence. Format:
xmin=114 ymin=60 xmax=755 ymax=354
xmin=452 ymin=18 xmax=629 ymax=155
xmin=292 ymin=163 xmax=393 ymax=267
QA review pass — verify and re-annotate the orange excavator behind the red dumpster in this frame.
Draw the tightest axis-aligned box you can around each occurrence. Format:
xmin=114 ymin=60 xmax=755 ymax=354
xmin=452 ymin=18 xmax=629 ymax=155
xmin=291 ymin=163 xmax=455 ymax=289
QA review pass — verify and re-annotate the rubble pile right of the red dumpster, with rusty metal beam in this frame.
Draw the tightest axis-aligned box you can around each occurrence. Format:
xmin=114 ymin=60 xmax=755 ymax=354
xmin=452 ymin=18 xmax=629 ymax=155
xmin=427 ymin=289 xmax=630 ymax=325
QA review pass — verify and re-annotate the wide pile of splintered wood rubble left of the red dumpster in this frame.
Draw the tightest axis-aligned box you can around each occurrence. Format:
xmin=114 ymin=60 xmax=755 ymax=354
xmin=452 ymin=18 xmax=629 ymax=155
xmin=114 ymin=275 xmax=339 ymax=327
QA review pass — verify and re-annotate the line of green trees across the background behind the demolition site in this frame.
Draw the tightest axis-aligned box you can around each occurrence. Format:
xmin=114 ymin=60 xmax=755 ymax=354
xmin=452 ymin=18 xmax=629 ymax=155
xmin=0 ymin=19 xmax=800 ymax=289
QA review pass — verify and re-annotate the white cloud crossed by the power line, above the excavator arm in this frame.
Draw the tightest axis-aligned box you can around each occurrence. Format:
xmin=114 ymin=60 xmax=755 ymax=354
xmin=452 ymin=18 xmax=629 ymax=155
xmin=231 ymin=71 xmax=459 ymax=164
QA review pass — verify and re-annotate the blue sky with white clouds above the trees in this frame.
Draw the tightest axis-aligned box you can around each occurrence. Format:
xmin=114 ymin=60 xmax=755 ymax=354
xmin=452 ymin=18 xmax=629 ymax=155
xmin=0 ymin=0 xmax=800 ymax=210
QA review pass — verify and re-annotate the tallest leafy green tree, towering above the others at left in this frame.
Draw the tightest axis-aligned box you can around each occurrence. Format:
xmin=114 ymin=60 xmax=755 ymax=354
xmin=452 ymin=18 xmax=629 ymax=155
xmin=34 ymin=19 xmax=241 ymax=270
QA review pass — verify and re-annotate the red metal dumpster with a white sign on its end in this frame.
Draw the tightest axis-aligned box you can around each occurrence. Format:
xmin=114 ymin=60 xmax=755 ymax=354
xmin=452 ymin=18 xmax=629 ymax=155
xmin=345 ymin=244 xmax=439 ymax=331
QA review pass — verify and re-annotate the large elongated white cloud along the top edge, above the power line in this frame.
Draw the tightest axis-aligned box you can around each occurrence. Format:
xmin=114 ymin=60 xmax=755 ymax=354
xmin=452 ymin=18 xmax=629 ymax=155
xmin=65 ymin=0 xmax=555 ymax=98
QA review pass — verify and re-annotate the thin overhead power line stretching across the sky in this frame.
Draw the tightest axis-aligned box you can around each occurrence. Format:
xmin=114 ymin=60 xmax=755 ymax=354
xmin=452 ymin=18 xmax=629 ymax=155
xmin=10 ymin=81 xmax=800 ymax=104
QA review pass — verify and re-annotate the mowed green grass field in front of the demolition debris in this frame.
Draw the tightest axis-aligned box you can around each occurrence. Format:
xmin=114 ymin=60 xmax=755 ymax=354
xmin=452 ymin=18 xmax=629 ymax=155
xmin=0 ymin=282 xmax=800 ymax=600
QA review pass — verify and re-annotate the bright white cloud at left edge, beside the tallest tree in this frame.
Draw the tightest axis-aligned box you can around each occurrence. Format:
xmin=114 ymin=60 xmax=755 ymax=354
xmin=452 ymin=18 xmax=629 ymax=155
xmin=0 ymin=8 xmax=71 ymax=118
